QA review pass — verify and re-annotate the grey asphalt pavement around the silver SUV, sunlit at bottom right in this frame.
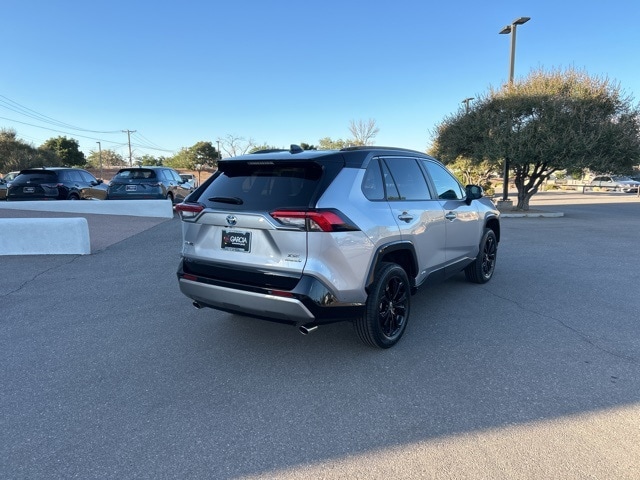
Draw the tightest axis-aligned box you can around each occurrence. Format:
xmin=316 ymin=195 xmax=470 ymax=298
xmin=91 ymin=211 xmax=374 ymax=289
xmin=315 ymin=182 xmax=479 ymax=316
xmin=0 ymin=193 xmax=640 ymax=479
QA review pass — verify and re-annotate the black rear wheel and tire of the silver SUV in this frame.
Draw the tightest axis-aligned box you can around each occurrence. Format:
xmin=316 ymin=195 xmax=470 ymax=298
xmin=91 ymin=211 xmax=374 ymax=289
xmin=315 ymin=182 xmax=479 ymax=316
xmin=355 ymin=263 xmax=411 ymax=348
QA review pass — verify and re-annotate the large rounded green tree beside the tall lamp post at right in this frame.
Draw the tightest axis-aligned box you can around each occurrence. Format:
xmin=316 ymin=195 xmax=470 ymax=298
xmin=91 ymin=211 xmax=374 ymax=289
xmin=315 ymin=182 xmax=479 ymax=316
xmin=434 ymin=69 xmax=640 ymax=210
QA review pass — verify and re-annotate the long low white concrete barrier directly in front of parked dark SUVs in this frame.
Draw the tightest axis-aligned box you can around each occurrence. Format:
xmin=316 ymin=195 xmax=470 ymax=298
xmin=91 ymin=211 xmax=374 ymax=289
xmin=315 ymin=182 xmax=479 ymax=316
xmin=0 ymin=200 xmax=173 ymax=218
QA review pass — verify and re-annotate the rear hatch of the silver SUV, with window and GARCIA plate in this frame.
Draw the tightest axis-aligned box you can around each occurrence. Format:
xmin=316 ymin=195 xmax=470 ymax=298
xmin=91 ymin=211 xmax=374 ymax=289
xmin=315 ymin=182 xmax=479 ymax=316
xmin=177 ymin=155 xmax=343 ymax=290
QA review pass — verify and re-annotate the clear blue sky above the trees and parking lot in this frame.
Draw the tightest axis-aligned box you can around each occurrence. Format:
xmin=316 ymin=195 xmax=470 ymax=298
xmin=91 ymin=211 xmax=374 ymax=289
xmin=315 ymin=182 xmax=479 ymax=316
xmin=0 ymin=0 xmax=640 ymax=161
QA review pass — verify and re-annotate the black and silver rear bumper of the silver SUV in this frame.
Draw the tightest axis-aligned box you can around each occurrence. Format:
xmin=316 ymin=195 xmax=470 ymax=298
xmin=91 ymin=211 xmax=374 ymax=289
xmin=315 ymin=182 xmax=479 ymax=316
xmin=178 ymin=266 xmax=364 ymax=326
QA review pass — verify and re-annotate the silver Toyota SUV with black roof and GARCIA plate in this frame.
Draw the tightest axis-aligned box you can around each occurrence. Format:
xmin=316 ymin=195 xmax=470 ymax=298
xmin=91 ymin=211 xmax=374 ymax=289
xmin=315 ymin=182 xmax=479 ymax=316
xmin=176 ymin=145 xmax=500 ymax=348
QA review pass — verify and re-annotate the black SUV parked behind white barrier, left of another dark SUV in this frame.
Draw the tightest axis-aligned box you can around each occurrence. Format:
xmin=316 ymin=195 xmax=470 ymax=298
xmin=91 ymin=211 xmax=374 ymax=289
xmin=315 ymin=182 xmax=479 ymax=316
xmin=7 ymin=167 xmax=107 ymax=201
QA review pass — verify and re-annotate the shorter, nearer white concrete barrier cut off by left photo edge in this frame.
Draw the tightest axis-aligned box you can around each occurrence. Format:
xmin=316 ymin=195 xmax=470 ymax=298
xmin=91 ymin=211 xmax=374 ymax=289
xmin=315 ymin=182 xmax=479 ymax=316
xmin=0 ymin=218 xmax=91 ymax=255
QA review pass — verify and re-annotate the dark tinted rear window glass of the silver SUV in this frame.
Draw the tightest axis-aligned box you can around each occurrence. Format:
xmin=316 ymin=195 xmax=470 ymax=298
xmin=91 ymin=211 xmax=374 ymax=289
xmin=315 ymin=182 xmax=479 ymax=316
xmin=198 ymin=162 xmax=323 ymax=210
